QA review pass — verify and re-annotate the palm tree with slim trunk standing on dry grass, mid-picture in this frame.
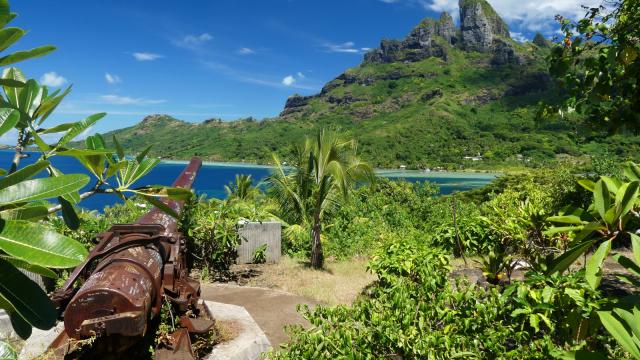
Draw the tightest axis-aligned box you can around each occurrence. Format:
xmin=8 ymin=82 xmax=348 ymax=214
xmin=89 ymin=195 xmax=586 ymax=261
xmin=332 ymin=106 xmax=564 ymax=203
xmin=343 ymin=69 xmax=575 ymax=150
xmin=267 ymin=130 xmax=374 ymax=268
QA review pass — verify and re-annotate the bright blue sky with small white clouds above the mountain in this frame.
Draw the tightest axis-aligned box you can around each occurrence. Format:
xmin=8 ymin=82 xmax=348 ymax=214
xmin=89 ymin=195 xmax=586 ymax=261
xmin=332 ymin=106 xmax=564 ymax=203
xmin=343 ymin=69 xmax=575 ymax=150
xmin=3 ymin=0 xmax=589 ymax=138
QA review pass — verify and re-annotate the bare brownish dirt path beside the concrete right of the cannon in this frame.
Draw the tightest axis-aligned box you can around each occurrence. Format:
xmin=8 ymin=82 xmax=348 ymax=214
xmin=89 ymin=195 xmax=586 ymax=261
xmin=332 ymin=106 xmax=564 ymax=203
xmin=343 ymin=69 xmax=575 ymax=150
xmin=202 ymin=284 xmax=318 ymax=348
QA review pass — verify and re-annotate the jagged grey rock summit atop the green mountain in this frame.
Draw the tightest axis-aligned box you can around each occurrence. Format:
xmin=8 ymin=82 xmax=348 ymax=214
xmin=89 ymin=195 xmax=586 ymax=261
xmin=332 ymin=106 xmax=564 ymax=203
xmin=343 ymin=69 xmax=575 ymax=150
xmin=364 ymin=0 xmax=522 ymax=65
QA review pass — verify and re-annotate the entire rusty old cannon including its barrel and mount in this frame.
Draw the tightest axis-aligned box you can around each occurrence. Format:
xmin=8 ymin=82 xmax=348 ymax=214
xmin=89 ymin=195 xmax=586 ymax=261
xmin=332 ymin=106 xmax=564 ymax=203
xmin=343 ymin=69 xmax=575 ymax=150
xmin=49 ymin=158 xmax=214 ymax=359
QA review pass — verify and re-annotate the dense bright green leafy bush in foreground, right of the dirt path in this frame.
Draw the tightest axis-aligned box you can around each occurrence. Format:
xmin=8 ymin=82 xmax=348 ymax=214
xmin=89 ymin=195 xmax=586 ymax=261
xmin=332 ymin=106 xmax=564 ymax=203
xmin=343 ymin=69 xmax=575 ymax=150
xmin=271 ymin=235 xmax=624 ymax=359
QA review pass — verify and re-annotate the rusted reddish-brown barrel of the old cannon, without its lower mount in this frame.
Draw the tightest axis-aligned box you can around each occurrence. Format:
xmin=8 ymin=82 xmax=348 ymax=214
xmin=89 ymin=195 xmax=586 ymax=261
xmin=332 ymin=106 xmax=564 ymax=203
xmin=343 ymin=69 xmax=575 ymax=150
xmin=61 ymin=158 xmax=202 ymax=339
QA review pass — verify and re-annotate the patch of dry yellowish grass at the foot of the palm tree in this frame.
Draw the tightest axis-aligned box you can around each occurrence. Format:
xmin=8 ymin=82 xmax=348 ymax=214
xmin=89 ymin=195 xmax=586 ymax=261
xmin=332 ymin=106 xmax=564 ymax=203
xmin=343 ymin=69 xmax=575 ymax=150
xmin=246 ymin=257 xmax=376 ymax=305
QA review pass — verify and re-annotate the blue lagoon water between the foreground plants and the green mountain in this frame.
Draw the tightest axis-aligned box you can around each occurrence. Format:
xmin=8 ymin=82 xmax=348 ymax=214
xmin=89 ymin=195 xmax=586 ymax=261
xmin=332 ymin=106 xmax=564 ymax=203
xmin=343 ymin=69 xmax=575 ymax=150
xmin=0 ymin=150 xmax=496 ymax=211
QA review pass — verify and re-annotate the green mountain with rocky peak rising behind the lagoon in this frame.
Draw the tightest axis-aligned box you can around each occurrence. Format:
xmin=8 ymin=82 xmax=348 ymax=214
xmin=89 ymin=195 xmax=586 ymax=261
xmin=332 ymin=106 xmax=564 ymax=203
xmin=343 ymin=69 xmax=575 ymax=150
xmin=107 ymin=0 xmax=637 ymax=168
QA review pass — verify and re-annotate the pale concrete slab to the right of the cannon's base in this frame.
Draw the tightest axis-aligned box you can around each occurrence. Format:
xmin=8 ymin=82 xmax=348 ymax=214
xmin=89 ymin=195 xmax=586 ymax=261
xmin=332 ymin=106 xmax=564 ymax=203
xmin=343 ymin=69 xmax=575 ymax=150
xmin=205 ymin=301 xmax=271 ymax=360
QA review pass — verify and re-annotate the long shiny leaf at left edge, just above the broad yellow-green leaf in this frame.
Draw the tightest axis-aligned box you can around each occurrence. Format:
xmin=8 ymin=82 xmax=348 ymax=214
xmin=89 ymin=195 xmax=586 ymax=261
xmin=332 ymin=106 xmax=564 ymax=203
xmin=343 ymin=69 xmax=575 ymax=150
xmin=0 ymin=174 xmax=89 ymax=205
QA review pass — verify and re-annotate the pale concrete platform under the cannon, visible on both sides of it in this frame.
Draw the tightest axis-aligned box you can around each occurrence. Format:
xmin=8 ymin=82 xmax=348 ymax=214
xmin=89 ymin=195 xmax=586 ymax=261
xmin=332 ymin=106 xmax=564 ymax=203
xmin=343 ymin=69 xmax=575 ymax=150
xmin=19 ymin=301 xmax=271 ymax=360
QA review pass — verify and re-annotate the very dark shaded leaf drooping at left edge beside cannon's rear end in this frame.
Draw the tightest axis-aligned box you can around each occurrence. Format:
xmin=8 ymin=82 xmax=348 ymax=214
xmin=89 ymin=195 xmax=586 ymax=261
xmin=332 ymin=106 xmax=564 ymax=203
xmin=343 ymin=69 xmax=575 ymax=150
xmin=0 ymin=259 xmax=57 ymax=330
